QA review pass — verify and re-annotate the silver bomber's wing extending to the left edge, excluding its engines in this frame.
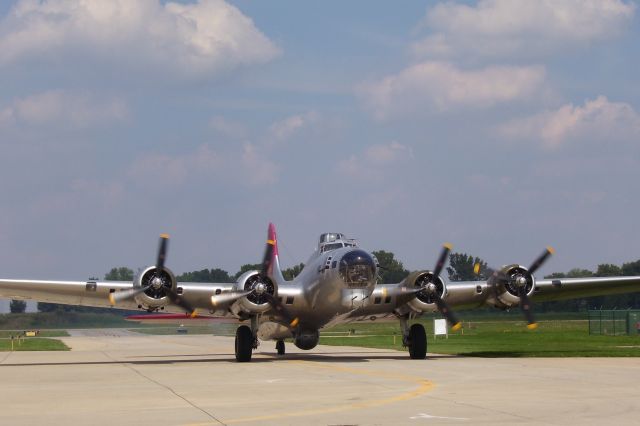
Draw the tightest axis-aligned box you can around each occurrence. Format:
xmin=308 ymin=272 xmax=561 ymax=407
xmin=0 ymin=279 xmax=233 ymax=313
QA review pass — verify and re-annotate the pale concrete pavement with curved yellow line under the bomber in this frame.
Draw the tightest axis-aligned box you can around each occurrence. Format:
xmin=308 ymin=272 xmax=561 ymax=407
xmin=0 ymin=330 xmax=640 ymax=425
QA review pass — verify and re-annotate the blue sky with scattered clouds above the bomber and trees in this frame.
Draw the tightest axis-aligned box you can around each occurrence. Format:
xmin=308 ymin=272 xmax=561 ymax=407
xmin=0 ymin=0 xmax=640 ymax=288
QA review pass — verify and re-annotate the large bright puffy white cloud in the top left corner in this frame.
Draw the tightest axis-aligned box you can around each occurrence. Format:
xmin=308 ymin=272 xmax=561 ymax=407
xmin=0 ymin=0 xmax=279 ymax=78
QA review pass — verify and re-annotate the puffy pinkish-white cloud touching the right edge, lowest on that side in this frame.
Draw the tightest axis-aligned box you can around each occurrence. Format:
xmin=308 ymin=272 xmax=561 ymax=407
xmin=499 ymin=96 xmax=640 ymax=148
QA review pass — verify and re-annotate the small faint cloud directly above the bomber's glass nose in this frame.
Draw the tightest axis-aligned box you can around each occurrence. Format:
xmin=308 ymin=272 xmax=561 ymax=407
xmin=337 ymin=141 xmax=413 ymax=180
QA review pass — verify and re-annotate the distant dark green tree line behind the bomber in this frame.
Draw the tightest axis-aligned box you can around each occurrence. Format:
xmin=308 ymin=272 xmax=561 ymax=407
xmin=10 ymin=250 xmax=640 ymax=312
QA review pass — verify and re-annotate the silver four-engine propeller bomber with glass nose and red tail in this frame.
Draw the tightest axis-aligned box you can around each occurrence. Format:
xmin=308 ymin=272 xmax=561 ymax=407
xmin=0 ymin=224 xmax=640 ymax=362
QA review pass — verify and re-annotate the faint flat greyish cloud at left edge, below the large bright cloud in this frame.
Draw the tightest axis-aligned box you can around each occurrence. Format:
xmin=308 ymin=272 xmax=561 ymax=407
xmin=0 ymin=90 xmax=129 ymax=128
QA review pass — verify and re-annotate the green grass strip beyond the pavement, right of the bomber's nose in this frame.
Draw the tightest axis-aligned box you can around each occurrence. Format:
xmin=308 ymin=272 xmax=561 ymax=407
xmin=320 ymin=320 xmax=640 ymax=357
